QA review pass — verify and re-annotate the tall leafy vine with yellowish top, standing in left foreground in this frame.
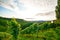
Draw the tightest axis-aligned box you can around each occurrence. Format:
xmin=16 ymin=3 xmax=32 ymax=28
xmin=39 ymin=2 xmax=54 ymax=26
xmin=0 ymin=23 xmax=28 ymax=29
xmin=7 ymin=18 xmax=21 ymax=40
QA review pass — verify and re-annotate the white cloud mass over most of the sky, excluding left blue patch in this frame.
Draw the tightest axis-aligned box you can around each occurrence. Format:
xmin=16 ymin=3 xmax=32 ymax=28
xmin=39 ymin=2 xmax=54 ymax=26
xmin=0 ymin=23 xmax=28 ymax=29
xmin=0 ymin=0 xmax=57 ymax=20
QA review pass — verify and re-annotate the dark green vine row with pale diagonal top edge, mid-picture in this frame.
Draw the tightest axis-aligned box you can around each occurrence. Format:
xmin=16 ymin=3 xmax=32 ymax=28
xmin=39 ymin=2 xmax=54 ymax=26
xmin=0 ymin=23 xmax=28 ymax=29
xmin=21 ymin=23 xmax=37 ymax=34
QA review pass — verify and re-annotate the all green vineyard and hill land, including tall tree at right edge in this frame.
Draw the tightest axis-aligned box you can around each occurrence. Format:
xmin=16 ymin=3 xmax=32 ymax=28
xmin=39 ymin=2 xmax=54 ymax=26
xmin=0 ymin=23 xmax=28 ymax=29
xmin=0 ymin=0 xmax=60 ymax=40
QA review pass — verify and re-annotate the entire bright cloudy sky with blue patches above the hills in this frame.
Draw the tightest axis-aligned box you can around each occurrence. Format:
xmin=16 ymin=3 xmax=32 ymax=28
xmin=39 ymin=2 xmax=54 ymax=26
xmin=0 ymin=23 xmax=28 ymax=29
xmin=0 ymin=0 xmax=57 ymax=21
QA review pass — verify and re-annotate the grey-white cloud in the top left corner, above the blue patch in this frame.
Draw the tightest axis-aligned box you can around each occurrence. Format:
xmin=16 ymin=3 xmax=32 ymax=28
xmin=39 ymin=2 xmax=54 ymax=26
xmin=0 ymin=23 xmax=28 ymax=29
xmin=0 ymin=0 xmax=19 ymax=11
